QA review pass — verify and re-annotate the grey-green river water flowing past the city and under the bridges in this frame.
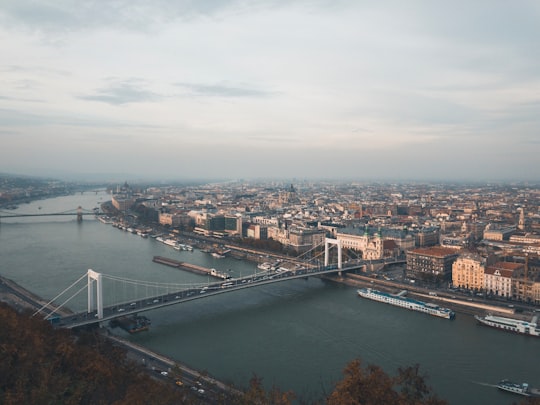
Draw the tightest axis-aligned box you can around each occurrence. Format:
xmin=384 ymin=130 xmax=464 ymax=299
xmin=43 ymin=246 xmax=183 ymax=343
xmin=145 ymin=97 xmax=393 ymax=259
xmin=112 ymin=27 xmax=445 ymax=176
xmin=0 ymin=192 xmax=540 ymax=405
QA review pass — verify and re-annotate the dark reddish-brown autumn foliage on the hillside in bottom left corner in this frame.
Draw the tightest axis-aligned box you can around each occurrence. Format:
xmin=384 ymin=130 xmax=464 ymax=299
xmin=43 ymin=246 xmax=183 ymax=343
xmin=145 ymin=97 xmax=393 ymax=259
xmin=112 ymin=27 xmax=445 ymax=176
xmin=0 ymin=304 xmax=184 ymax=405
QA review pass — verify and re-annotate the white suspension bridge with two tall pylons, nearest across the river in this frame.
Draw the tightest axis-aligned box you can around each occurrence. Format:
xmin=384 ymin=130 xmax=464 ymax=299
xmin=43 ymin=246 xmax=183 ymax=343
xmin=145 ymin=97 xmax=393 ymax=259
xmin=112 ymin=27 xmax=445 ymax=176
xmin=34 ymin=238 xmax=380 ymax=328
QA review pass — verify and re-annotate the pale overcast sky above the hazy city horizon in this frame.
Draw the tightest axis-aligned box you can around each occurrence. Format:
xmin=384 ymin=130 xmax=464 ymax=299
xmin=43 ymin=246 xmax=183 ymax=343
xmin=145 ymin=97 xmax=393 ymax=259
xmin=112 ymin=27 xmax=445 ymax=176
xmin=0 ymin=0 xmax=540 ymax=181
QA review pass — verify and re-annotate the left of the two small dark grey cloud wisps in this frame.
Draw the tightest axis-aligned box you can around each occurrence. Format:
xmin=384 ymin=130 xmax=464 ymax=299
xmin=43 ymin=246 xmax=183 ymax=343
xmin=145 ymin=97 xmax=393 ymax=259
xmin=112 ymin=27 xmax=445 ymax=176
xmin=78 ymin=79 xmax=163 ymax=105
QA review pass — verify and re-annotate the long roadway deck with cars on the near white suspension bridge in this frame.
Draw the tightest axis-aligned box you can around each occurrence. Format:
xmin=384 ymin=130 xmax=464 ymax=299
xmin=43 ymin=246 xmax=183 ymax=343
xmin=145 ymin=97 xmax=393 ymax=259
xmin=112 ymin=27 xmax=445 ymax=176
xmin=62 ymin=261 xmax=366 ymax=328
